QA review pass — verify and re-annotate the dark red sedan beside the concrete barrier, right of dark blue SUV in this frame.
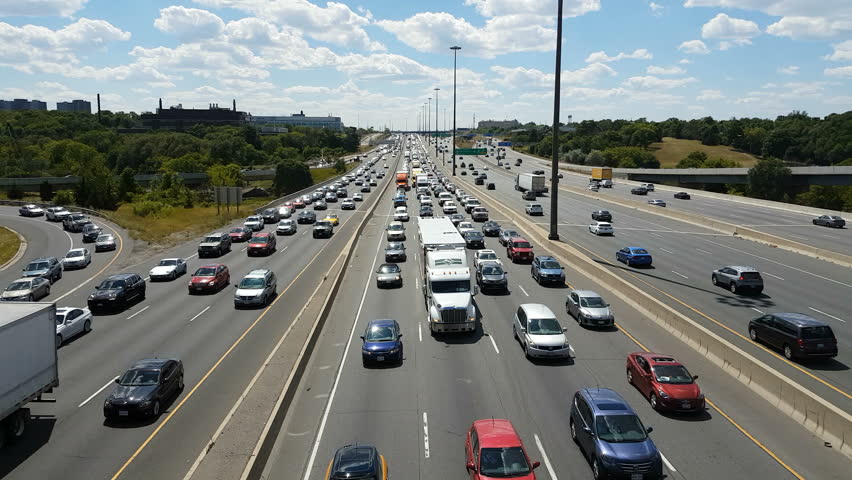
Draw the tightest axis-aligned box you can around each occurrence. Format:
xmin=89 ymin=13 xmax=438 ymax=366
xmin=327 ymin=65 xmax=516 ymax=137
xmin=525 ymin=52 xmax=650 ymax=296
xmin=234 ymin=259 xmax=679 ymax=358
xmin=627 ymin=352 xmax=704 ymax=412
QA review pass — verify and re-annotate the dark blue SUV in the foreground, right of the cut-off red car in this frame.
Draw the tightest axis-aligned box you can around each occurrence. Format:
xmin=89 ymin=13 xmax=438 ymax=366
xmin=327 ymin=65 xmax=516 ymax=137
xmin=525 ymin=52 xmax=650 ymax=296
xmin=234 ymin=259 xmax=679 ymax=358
xmin=570 ymin=388 xmax=663 ymax=480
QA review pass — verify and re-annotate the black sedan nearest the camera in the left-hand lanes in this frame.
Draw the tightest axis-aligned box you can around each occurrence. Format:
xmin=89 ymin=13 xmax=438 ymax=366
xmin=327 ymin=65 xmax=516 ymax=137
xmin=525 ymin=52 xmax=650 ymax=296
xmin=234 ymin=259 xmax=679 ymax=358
xmin=104 ymin=358 xmax=183 ymax=420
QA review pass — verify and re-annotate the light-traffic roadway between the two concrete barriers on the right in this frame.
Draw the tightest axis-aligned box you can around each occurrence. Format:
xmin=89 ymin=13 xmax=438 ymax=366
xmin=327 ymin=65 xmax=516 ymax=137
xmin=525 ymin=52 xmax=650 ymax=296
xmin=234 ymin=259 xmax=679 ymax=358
xmin=448 ymin=136 xmax=852 ymax=411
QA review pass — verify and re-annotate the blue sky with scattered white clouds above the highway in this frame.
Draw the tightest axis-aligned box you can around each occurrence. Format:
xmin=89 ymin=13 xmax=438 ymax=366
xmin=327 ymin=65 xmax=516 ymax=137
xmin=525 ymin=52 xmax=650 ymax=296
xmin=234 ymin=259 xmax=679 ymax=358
xmin=0 ymin=0 xmax=852 ymax=128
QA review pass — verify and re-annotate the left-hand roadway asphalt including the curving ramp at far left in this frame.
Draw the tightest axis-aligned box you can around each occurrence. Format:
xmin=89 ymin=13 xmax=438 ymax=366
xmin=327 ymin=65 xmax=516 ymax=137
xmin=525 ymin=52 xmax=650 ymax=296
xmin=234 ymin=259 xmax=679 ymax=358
xmin=0 ymin=147 xmax=400 ymax=480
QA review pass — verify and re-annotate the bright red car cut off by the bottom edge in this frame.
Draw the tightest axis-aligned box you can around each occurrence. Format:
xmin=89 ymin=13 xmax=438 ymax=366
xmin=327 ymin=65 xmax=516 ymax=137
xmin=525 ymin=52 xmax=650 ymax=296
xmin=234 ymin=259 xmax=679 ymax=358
xmin=464 ymin=418 xmax=539 ymax=480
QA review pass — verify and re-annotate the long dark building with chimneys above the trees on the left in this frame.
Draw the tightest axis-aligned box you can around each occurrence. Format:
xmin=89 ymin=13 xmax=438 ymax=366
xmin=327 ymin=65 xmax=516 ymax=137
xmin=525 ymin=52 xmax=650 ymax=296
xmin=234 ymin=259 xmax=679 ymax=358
xmin=139 ymin=99 xmax=251 ymax=132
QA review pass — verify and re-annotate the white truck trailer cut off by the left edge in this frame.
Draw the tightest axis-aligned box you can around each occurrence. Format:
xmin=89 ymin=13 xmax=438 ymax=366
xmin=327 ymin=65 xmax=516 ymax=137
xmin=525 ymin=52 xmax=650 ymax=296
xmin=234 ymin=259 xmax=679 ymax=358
xmin=0 ymin=302 xmax=59 ymax=447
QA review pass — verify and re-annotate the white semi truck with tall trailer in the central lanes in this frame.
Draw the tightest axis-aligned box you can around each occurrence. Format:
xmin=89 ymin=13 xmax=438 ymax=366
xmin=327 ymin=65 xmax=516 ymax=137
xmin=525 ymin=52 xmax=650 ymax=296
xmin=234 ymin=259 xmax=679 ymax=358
xmin=417 ymin=217 xmax=478 ymax=334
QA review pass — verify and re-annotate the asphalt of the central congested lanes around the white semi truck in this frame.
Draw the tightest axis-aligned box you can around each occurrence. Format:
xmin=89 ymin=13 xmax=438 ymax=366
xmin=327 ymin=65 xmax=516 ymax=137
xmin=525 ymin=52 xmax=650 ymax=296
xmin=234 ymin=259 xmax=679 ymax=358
xmin=263 ymin=135 xmax=848 ymax=480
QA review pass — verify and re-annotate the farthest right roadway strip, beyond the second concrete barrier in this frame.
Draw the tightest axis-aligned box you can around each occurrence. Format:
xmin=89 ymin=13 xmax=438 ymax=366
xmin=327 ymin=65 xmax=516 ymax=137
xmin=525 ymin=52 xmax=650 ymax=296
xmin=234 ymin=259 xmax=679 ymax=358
xmin=500 ymin=147 xmax=852 ymax=254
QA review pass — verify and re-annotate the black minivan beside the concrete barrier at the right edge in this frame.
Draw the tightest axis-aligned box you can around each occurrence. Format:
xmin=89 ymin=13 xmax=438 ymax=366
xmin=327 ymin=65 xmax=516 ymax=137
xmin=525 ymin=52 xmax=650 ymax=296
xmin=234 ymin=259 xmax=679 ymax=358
xmin=748 ymin=313 xmax=837 ymax=360
